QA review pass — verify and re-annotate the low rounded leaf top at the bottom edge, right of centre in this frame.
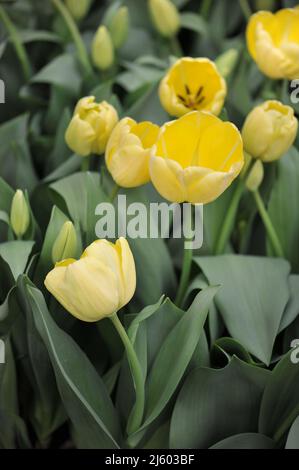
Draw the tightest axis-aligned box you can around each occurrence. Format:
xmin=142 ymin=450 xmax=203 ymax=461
xmin=210 ymin=432 xmax=275 ymax=449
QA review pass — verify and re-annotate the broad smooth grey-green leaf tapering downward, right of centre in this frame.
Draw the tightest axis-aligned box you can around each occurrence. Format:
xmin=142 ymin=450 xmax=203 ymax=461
xmin=195 ymin=255 xmax=290 ymax=364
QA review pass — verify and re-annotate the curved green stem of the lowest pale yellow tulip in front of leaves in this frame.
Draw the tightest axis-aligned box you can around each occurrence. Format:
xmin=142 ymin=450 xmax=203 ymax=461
xmin=110 ymin=313 xmax=145 ymax=435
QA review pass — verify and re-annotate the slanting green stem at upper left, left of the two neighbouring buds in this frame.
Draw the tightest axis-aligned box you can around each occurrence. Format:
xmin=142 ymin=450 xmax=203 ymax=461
xmin=52 ymin=0 xmax=92 ymax=75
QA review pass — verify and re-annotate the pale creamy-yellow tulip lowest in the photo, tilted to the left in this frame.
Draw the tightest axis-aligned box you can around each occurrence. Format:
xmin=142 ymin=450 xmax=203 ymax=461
xmin=45 ymin=238 xmax=136 ymax=322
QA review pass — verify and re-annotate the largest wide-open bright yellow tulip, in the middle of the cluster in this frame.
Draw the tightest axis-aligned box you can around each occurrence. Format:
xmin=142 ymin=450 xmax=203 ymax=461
xmin=150 ymin=111 xmax=244 ymax=204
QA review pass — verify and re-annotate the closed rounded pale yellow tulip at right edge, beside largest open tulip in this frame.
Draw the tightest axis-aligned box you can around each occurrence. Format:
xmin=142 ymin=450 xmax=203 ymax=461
xmin=242 ymin=100 xmax=298 ymax=162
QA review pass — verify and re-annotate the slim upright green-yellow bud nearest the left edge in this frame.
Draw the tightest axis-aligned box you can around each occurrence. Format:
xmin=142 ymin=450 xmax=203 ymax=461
xmin=10 ymin=189 xmax=30 ymax=238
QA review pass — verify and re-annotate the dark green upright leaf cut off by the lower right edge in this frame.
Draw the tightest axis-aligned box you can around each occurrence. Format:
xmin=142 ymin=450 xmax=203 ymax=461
xmin=259 ymin=351 xmax=299 ymax=442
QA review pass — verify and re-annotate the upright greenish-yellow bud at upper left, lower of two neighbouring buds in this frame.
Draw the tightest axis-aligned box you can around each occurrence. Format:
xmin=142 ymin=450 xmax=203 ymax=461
xmin=91 ymin=25 xmax=114 ymax=70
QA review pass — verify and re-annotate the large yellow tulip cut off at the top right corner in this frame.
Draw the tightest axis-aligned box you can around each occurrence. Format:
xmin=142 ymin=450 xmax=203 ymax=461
xmin=247 ymin=8 xmax=299 ymax=80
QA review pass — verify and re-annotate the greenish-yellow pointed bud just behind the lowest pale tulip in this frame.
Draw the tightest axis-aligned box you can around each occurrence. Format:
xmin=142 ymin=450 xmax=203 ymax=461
xmin=52 ymin=221 xmax=77 ymax=264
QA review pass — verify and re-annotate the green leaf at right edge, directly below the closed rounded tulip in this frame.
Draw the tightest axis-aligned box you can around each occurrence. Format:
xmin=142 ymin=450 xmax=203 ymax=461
xmin=268 ymin=147 xmax=299 ymax=273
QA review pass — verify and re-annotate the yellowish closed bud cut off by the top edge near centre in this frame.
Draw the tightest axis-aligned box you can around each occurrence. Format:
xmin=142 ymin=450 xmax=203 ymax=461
xmin=149 ymin=0 xmax=180 ymax=38
